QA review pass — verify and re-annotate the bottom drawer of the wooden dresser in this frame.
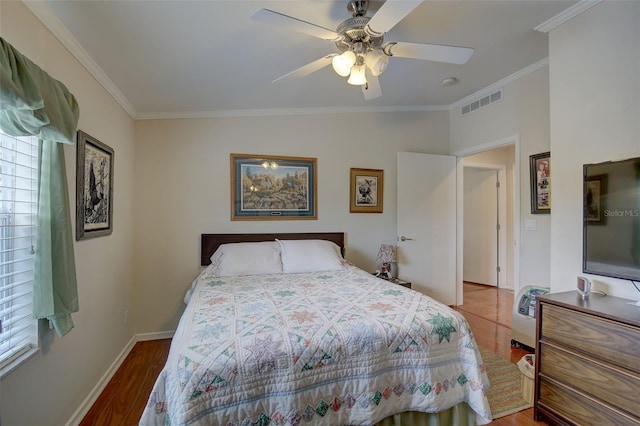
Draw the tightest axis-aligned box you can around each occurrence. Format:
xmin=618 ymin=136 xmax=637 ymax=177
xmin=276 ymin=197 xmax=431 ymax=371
xmin=538 ymin=377 xmax=640 ymax=425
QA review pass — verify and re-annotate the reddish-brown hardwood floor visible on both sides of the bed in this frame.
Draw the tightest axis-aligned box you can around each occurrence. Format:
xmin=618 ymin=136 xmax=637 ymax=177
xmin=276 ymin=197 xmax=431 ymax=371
xmin=80 ymin=283 xmax=545 ymax=426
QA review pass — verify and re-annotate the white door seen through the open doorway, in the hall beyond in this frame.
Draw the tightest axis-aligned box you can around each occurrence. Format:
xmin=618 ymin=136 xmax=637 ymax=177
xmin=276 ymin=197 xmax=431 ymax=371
xmin=462 ymin=167 xmax=499 ymax=286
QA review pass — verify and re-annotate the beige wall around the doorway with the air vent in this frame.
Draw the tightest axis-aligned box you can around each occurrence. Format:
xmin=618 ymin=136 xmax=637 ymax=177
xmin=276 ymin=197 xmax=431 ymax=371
xmin=449 ymin=66 xmax=555 ymax=292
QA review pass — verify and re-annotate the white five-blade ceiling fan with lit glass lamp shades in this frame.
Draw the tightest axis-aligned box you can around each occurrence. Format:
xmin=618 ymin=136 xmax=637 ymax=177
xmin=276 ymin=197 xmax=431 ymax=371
xmin=251 ymin=0 xmax=473 ymax=100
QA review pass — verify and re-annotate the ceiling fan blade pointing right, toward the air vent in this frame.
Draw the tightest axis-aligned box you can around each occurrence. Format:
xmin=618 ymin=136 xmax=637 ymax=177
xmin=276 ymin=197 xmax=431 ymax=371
xmin=383 ymin=42 xmax=473 ymax=64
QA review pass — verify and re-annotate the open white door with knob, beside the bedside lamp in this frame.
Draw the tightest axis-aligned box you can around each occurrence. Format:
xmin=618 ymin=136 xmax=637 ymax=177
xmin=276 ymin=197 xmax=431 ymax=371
xmin=397 ymin=152 xmax=456 ymax=305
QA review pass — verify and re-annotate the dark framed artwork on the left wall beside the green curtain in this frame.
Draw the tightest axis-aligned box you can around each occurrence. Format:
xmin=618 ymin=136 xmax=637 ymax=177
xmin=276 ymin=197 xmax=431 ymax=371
xmin=76 ymin=130 xmax=114 ymax=240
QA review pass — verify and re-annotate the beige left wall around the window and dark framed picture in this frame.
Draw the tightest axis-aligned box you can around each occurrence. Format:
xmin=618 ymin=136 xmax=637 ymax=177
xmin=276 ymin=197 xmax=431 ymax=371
xmin=0 ymin=1 xmax=134 ymax=426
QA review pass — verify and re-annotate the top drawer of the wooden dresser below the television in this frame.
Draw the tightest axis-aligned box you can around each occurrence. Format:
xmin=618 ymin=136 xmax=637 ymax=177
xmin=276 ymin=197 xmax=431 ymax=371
xmin=540 ymin=304 xmax=640 ymax=373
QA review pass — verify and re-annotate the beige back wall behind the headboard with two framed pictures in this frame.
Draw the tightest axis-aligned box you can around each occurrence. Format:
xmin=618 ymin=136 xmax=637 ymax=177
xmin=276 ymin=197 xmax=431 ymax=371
xmin=135 ymin=111 xmax=449 ymax=333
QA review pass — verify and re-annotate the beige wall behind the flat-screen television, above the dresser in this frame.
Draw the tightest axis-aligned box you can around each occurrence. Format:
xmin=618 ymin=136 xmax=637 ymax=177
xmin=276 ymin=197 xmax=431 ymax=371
xmin=549 ymin=1 xmax=640 ymax=300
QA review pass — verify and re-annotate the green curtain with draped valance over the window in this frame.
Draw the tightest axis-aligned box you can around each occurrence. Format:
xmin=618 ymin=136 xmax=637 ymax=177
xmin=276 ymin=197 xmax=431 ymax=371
xmin=0 ymin=37 xmax=80 ymax=336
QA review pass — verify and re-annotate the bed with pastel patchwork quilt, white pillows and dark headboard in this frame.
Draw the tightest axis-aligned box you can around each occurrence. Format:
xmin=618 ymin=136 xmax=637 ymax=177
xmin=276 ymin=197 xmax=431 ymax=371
xmin=140 ymin=232 xmax=491 ymax=426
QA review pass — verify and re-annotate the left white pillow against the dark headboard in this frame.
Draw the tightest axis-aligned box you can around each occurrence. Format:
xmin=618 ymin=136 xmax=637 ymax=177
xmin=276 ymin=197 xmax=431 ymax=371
xmin=211 ymin=241 xmax=282 ymax=277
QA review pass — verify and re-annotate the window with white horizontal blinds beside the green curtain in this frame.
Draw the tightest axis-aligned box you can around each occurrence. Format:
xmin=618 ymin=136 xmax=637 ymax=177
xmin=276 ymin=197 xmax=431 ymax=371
xmin=0 ymin=130 xmax=38 ymax=372
